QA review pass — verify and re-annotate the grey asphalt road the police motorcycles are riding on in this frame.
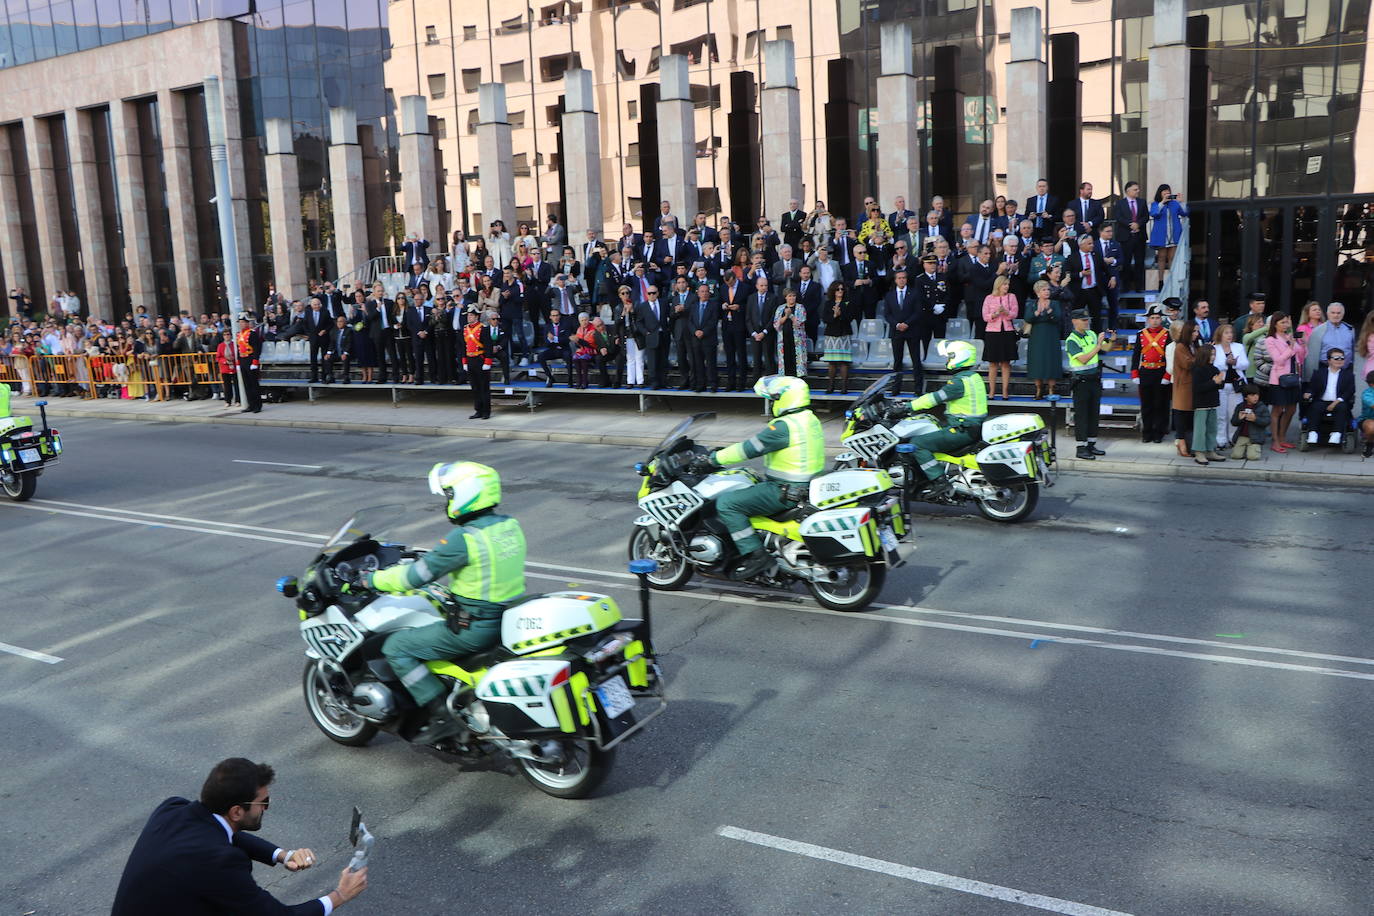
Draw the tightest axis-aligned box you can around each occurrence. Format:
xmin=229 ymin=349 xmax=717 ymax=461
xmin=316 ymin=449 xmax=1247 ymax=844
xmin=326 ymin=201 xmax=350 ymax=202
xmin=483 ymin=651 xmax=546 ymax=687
xmin=0 ymin=420 xmax=1374 ymax=916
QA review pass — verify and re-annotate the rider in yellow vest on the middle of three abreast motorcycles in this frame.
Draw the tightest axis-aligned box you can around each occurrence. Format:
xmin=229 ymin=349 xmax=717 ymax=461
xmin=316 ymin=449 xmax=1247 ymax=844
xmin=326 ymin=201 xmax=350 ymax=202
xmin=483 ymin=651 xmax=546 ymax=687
xmin=705 ymin=375 xmax=826 ymax=580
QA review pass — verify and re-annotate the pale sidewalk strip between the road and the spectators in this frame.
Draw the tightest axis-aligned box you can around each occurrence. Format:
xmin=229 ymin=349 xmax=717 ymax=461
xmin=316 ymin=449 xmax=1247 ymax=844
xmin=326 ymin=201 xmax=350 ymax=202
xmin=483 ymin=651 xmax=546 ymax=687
xmin=11 ymin=393 xmax=1374 ymax=486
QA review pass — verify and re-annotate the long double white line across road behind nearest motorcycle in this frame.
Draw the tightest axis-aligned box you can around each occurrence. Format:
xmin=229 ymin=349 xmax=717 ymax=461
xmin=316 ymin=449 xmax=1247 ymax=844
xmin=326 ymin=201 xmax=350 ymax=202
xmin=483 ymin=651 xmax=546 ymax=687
xmin=10 ymin=500 xmax=1374 ymax=681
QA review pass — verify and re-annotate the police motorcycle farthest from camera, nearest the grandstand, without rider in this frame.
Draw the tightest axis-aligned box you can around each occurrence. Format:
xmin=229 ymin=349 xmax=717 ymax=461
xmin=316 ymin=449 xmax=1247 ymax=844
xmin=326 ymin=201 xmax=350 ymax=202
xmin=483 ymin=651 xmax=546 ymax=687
xmin=835 ymin=372 xmax=1055 ymax=522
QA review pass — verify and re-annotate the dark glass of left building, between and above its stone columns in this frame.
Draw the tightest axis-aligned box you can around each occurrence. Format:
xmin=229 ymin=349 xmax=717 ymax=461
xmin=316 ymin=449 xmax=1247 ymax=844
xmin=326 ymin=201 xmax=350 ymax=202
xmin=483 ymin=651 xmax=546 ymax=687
xmin=0 ymin=0 xmax=396 ymax=314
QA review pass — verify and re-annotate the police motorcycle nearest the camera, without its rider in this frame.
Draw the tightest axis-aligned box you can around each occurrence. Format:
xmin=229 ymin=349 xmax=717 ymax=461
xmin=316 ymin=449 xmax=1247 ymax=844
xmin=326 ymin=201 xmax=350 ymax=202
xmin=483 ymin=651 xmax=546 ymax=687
xmin=278 ymin=507 xmax=668 ymax=798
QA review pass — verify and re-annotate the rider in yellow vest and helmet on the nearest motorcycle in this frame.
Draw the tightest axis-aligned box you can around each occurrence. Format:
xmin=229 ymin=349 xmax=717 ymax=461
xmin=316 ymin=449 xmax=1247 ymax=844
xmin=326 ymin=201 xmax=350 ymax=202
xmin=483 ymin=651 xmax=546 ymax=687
xmin=363 ymin=461 xmax=525 ymax=744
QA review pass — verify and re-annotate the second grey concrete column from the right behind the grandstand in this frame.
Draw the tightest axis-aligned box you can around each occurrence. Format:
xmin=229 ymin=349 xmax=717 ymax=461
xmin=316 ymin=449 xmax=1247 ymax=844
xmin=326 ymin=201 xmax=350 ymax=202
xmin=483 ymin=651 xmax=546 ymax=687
xmin=1006 ymin=7 xmax=1050 ymax=201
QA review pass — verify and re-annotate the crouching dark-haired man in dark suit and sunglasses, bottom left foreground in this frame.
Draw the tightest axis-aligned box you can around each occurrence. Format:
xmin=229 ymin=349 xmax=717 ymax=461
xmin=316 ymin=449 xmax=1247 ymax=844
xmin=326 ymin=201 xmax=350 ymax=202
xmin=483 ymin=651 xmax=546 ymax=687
xmin=111 ymin=757 xmax=367 ymax=916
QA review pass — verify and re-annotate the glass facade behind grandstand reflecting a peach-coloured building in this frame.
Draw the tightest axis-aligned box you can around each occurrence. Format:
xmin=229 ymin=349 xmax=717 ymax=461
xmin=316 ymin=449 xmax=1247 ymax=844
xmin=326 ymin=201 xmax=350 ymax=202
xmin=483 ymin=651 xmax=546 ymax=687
xmin=387 ymin=0 xmax=1374 ymax=322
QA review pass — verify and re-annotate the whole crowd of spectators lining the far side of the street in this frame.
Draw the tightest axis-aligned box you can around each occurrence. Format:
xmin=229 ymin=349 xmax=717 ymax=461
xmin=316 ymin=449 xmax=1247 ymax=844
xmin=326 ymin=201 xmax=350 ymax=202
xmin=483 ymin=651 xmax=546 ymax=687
xmin=3 ymin=180 xmax=1374 ymax=461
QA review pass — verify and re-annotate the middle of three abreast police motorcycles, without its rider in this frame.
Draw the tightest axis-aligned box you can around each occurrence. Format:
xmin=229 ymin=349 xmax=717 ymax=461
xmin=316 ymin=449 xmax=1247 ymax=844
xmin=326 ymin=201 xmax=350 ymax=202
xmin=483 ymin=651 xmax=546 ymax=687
xmin=629 ymin=413 xmax=905 ymax=611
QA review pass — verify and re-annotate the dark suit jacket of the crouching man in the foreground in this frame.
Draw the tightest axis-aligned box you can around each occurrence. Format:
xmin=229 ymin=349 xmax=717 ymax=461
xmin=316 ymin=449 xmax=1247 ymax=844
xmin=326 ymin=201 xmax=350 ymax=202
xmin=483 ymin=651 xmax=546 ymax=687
xmin=110 ymin=798 xmax=324 ymax=916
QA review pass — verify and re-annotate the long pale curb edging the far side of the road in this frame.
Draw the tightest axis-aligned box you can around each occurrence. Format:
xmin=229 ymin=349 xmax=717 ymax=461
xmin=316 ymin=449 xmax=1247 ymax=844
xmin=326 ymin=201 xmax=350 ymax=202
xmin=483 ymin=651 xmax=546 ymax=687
xmin=34 ymin=408 xmax=1374 ymax=488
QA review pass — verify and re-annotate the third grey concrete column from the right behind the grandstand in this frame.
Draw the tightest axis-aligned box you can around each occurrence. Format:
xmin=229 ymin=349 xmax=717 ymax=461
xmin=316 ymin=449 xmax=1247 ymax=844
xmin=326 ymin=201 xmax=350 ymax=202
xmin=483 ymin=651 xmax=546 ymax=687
xmin=873 ymin=22 xmax=925 ymax=224
